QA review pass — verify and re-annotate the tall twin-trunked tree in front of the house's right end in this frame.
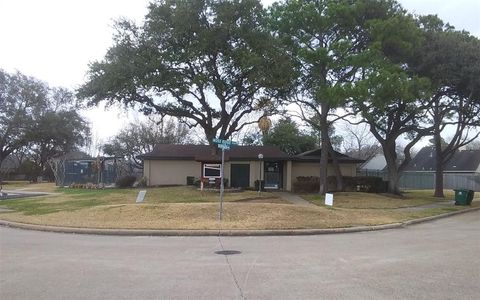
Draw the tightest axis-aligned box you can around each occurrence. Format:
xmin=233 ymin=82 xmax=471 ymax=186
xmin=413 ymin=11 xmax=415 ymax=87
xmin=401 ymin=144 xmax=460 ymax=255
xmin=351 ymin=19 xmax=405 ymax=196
xmin=270 ymin=0 xmax=404 ymax=193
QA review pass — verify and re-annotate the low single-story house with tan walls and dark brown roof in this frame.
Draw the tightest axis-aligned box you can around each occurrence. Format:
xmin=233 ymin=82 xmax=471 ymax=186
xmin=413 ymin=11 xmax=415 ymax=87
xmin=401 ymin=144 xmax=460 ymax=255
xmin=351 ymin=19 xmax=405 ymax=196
xmin=141 ymin=145 xmax=363 ymax=191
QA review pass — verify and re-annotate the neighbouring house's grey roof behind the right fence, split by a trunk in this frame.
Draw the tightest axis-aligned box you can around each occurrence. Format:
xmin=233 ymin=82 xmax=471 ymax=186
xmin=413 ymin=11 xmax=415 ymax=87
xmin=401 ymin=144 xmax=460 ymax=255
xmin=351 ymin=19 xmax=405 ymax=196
xmin=405 ymin=147 xmax=480 ymax=172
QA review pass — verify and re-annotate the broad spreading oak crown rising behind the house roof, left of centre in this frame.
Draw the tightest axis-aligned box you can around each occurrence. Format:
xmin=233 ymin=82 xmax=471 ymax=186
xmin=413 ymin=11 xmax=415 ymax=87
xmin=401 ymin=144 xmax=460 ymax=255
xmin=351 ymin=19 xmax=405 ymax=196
xmin=79 ymin=0 xmax=291 ymax=143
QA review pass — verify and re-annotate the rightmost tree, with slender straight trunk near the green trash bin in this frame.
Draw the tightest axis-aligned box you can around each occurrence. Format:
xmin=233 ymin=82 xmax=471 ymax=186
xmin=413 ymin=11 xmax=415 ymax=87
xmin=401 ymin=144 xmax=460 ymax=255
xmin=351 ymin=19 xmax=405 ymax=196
xmin=412 ymin=16 xmax=480 ymax=197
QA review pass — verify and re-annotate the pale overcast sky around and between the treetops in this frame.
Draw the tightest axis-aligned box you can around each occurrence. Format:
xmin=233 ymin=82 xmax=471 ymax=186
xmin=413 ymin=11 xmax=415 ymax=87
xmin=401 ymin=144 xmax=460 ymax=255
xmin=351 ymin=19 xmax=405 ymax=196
xmin=0 ymin=0 xmax=480 ymax=144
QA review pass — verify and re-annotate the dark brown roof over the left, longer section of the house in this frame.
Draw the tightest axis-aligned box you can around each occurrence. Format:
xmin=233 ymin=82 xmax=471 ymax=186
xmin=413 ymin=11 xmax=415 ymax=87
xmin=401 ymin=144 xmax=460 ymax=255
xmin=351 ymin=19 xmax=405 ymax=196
xmin=141 ymin=144 xmax=290 ymax=161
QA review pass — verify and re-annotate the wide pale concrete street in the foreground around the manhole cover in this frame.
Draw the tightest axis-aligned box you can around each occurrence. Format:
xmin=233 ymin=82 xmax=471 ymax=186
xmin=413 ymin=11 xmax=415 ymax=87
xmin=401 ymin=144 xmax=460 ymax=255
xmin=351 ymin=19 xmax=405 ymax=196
xmin=0 ymin=211 xmax=480 ymax=299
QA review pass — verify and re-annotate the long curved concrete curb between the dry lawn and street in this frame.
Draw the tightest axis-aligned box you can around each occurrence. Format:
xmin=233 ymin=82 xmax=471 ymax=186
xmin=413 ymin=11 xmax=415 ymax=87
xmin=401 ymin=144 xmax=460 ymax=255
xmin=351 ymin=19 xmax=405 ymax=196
xmin=0 ymin=207 xmax=480 ymax=236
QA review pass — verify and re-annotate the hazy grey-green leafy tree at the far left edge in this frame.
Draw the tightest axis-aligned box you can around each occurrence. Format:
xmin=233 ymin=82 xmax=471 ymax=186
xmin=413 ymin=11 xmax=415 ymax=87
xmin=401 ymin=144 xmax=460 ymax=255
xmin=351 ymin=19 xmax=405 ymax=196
xmin=0 ymin=70 xmax=90 ymax=179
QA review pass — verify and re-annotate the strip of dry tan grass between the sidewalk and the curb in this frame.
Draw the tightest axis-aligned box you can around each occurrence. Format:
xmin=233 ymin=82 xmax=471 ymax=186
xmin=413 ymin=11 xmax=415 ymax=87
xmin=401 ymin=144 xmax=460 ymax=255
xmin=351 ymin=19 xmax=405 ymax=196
xmin=0 ymin=202 xmax=468 ymax=229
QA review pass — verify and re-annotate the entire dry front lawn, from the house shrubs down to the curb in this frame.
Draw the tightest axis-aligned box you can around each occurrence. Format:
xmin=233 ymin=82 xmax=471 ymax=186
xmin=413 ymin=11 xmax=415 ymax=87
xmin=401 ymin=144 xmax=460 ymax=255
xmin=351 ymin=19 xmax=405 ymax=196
xmin=0 ymin=183 xmax=472 ymax=229
